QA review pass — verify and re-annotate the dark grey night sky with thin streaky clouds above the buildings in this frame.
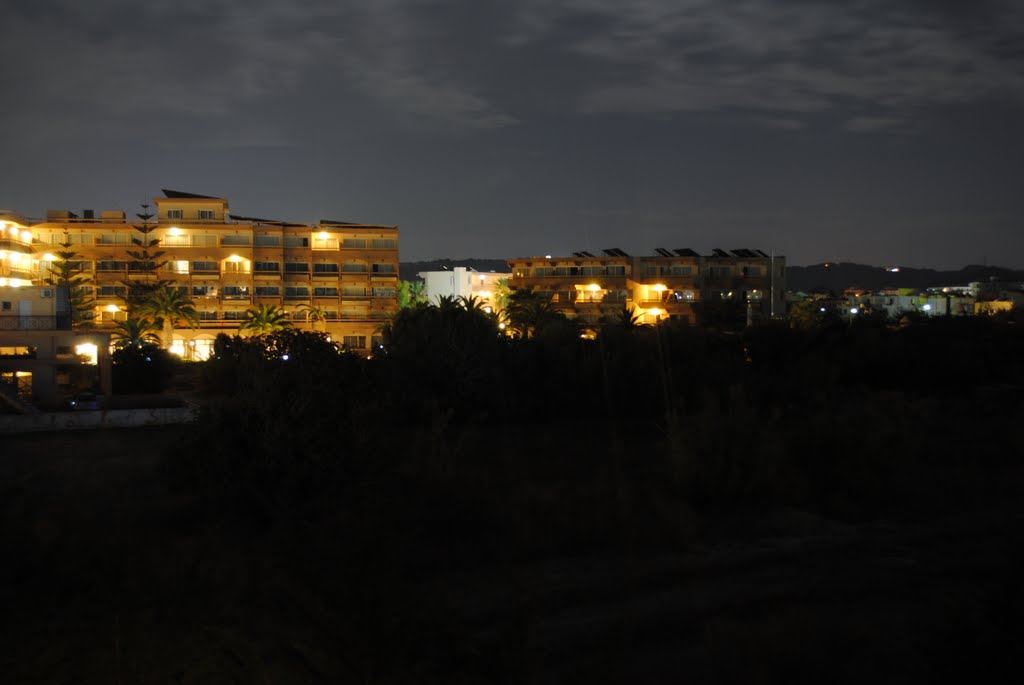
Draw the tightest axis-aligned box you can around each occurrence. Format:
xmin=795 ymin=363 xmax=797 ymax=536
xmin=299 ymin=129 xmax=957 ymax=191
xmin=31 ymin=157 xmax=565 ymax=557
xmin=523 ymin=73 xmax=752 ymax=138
xmin=0 ymin=0 xmax=1024 ymax=268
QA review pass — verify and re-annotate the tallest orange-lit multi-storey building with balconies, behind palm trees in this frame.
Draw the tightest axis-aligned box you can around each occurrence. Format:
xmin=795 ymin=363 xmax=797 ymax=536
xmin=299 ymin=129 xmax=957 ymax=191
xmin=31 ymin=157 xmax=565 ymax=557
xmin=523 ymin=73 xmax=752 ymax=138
xmin=24 ymin=190 xmax=398 ymax=358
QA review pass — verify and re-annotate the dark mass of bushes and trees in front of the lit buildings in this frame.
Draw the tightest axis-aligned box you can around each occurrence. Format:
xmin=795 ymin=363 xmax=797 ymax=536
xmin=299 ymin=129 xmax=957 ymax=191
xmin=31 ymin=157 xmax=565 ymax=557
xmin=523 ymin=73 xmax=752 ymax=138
xmin=167 ymin=300 xmax=1024 ymax=532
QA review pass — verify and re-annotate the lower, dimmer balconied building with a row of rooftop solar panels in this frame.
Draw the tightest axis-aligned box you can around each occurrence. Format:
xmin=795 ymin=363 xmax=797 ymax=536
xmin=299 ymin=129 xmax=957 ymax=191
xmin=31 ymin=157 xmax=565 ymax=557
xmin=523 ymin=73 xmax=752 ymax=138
xmin=509 ymin=248 xmax=785 ymax=324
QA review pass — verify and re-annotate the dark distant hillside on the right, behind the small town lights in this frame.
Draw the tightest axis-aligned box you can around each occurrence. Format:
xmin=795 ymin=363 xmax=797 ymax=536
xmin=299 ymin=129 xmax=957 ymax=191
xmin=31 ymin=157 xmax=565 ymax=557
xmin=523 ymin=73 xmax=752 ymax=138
xmin=785 ymin=262 xmax=1024 ymax=293
